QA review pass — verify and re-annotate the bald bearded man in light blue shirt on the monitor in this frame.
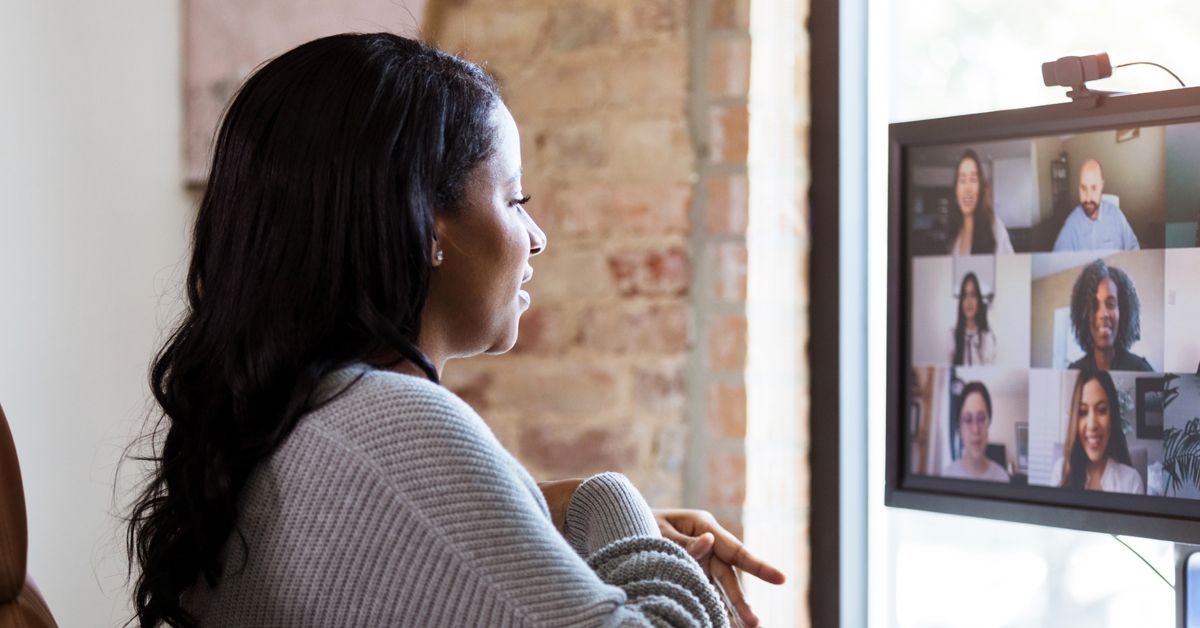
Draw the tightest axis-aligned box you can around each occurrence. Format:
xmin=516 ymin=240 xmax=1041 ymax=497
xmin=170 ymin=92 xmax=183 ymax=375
xmin=1054 ymin=160 xmax=1139 ymax=251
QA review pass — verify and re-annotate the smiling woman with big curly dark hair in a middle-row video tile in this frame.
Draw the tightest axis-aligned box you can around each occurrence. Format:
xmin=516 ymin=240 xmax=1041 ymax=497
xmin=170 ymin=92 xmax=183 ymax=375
xmin=1069 ymin=259 xmax=1154 ymax=371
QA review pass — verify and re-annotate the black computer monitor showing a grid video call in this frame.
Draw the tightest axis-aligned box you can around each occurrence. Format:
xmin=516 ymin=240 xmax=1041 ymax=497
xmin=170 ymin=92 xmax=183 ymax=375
xmin=886 ymin=88 xmax=1200 ymax=543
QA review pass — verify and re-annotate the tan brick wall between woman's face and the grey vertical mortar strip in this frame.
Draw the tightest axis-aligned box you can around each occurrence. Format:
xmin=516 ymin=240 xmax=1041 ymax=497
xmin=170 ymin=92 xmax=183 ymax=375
xmin=427 ymin=0 xmax=700 ymax=506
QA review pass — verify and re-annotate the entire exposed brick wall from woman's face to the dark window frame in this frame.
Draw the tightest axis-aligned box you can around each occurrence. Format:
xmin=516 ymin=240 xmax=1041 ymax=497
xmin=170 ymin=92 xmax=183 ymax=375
xmin=426 ymin=0 xmax=808 ymax=624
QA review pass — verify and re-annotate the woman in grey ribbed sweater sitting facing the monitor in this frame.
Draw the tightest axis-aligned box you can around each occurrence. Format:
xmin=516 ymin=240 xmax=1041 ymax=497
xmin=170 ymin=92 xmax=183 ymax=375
xmin=128 ymin=34 xmax=782 ymax=626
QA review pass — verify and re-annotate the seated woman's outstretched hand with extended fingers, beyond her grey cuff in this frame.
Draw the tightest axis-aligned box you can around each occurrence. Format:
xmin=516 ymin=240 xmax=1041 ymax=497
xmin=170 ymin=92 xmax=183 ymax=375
xmin=654 ymin=509 xmax=785 ymax=626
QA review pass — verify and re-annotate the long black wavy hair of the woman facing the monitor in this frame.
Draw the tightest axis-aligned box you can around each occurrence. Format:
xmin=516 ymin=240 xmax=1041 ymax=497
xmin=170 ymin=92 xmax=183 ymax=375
xmin=126 ymin=34 xmax=500 ymax=627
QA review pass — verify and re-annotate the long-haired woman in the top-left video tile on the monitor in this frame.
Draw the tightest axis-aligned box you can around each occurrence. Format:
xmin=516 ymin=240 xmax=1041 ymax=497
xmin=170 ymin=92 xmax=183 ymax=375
xmin=948 ymin=149 xmax=1013 ymax=256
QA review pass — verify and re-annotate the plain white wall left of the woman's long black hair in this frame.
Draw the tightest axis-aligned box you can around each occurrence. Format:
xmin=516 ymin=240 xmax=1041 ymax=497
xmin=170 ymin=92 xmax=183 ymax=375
xmin=0 ymin=0 xmax=191 ymax=626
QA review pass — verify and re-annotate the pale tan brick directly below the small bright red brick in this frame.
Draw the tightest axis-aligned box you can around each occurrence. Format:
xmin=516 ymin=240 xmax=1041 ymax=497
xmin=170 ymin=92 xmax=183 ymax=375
xmin=580 ymin=303 xmax=689 ymax=355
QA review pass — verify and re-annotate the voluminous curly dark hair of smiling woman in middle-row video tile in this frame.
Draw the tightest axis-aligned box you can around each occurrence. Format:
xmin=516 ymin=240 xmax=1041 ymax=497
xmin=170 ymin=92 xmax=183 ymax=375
xmin=1070 ymin=259 xmax=1141 ymax=355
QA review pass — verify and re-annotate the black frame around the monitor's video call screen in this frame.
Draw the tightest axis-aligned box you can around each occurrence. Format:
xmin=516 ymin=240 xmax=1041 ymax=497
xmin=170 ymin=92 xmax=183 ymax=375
xmin=883 ymin=88 xmax=1200 ymax=544
